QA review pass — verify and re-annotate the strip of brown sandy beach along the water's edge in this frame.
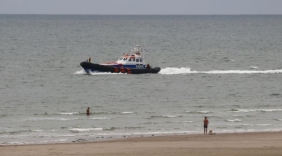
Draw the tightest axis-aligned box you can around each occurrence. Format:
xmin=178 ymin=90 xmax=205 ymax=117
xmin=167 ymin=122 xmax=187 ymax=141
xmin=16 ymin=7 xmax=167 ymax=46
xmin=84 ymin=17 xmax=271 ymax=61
xmin=0 ymin=132 xmax=282 ymax=156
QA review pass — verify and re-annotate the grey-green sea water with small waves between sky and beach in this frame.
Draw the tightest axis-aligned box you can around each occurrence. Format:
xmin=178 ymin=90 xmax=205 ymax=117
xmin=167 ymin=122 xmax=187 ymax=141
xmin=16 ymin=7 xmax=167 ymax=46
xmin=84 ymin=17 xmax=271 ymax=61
xmin=0 ymin=15 xmax=282 ymax=145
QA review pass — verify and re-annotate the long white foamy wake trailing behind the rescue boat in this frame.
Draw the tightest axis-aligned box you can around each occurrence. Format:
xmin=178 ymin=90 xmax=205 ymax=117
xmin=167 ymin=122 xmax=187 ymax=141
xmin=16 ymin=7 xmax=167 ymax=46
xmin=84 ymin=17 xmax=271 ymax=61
xmin=159 ymin=67 xmax=282 ymax=75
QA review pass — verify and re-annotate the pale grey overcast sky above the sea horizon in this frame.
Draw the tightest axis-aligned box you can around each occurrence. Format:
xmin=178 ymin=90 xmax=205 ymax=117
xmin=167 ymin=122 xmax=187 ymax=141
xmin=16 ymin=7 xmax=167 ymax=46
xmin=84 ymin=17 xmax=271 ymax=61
xmin=0 ymin=0 xmax=282 ymax=15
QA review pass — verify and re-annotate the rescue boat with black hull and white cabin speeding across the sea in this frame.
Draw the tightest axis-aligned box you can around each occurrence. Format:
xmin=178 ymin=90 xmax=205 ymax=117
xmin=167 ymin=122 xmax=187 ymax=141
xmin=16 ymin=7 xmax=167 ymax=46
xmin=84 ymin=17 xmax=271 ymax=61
xmin=80 ymin=45 xmax=161 ymax=74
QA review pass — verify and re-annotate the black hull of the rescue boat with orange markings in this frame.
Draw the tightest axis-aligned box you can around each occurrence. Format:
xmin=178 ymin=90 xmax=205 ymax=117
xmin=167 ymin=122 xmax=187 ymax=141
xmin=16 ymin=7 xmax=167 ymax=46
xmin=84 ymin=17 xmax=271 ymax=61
xmin=80 ymin=62 xmax=161 ymax=74
